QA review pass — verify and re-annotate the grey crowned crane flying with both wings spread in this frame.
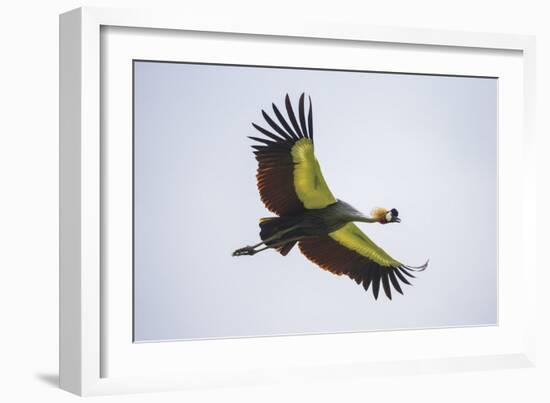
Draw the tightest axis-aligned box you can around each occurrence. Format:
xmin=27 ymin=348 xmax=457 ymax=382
xmin=233 ymin=94 xmax=428 ymax=299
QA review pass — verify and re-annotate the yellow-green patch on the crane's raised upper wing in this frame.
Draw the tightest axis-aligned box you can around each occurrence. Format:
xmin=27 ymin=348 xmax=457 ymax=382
xmin=291 ymin=138 xmax=336 ymax=209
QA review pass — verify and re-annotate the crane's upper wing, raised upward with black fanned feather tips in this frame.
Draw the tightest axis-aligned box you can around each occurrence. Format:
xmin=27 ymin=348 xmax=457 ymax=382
xmin=249 ymin=94 xmax=336 ymax=215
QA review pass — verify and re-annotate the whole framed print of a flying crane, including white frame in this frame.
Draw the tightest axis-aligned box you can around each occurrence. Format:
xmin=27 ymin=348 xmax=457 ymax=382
xmin=60 ymin=8 xmax=536 ymax=394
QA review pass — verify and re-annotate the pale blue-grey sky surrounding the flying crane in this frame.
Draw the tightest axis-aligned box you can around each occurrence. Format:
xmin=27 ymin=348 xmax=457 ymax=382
xmin=134 ymin=62 xmax=498 ymax=341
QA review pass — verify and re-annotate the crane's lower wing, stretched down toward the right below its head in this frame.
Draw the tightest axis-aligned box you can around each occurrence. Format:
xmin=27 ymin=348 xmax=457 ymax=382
xmin=300 ymin=223 xmax=428 ymax=299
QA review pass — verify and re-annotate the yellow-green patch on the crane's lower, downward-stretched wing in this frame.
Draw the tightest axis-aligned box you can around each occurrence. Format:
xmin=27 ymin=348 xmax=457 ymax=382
xmin=329 ymin=222 xmax=402 ymax=267
